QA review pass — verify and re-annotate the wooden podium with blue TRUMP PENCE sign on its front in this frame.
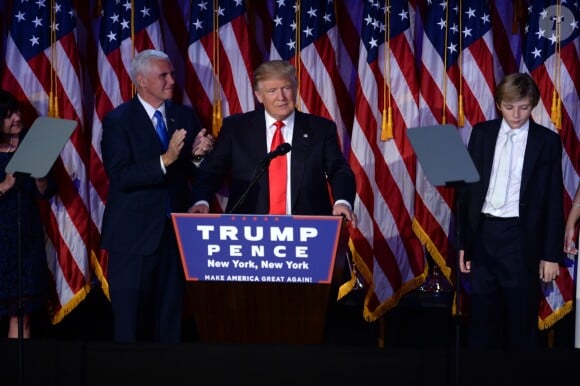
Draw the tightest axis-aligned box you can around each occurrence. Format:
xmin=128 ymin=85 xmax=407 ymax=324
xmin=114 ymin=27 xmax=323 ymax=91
xmin=174 ymin=214 xmax=348 ymax=344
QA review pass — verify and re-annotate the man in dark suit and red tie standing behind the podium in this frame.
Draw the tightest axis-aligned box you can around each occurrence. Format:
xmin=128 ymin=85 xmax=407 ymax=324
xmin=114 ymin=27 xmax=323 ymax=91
xmin=190 ymin=60 xmax=356 ymax=225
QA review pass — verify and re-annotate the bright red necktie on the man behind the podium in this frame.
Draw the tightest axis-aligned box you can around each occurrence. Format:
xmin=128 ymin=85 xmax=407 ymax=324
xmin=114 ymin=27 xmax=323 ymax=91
xmin=268 ymin=121 xmax=287 ymax=214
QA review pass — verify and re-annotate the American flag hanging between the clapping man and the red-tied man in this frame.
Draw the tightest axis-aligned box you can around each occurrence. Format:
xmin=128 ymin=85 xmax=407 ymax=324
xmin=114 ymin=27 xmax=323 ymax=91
xmin=186 ymin=0 xmax=255 ymax=135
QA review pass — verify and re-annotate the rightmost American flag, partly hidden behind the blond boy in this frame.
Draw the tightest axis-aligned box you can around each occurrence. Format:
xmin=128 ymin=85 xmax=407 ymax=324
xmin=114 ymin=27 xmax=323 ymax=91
xmin=521 ymin=0 xmax=580 ymax=328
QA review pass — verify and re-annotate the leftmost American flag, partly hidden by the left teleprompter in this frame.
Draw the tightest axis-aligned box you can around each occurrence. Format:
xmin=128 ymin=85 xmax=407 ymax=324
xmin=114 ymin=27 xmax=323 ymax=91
xmin=2 ymin=0 xmax=95 ymax=323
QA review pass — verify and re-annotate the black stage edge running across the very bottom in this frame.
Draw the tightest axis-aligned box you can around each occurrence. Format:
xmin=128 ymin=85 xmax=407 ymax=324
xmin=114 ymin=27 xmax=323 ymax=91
xmin=0 ymin=340 xmax=580 ymax=386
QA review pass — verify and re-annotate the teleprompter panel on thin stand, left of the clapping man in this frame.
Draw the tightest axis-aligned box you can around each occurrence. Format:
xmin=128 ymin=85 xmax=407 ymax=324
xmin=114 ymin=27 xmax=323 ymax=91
xmin=6 ymin=117 xmax=77 ymax=385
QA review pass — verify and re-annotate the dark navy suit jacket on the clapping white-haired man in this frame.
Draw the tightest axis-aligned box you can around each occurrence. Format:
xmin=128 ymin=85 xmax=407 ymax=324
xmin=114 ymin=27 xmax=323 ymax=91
xmin=101 ymin=97 xmax=201 ymax=255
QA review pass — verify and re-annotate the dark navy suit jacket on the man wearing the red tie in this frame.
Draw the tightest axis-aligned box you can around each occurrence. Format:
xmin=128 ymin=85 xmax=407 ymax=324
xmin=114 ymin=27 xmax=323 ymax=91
xmin=194 ymin=108 xmax=356 ymax=215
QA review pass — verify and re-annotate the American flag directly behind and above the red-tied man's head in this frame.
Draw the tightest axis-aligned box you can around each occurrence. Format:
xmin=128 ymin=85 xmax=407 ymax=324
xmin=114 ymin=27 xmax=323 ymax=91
xmin=270 ymin=0 xmax=354 ymax=153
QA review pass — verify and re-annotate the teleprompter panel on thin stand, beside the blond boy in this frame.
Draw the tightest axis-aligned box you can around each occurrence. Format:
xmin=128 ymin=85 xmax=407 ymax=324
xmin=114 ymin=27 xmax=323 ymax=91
xmin=407 ymin=125 xmax=479 ymax=386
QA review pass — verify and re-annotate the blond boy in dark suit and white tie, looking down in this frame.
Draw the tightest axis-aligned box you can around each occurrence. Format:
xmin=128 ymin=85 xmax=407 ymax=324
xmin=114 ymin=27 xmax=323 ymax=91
xmin=458 ymin=73 xmax=564 ymax=349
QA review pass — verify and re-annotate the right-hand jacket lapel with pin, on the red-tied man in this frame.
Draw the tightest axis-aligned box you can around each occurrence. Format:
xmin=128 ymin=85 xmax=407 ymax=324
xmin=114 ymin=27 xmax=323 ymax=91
xmin=290 ymin=111 xmax=313 ymax=208
